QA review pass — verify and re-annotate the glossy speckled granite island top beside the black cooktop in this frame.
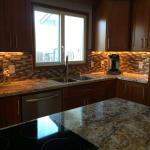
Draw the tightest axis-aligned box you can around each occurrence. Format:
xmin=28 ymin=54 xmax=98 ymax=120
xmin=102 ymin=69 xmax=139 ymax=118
xmin=52 ymin=99 xmax=150 ymax=150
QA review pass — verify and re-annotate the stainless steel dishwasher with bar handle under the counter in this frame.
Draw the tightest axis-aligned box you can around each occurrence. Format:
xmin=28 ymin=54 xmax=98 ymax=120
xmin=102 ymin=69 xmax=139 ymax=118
xmin=22 ymin=90 xmax=62 ymax=121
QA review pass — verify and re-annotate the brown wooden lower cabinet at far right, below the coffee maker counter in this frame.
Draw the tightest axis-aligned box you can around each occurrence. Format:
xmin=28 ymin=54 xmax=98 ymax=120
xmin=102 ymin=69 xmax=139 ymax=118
xmin=116 ymin=80 xmax=146 ymax=104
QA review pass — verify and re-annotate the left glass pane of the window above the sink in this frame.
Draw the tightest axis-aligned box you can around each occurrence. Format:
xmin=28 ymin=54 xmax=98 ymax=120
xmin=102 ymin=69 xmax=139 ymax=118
xmin=34 ymin=10 xmax=61 ymax=63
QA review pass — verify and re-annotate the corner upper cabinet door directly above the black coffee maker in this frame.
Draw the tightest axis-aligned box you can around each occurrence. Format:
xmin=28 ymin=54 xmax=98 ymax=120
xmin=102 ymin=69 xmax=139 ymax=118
xmin=107 ymin=0 xmax=130 ymax=51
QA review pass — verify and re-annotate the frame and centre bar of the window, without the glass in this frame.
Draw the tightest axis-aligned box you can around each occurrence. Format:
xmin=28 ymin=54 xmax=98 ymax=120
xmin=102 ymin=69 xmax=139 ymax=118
xmin=32 ymin=4 xmax=88 ymax=67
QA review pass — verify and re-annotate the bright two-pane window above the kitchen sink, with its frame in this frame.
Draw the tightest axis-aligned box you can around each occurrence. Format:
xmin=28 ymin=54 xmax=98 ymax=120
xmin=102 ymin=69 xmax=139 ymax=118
xmin=34 ymin=7 xmax=86 ymax=66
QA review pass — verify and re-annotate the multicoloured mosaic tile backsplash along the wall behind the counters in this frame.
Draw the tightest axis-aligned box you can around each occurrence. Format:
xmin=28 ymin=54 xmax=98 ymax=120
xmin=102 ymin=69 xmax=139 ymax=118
xmin=0 ymin=51 xmax=150 ymax=82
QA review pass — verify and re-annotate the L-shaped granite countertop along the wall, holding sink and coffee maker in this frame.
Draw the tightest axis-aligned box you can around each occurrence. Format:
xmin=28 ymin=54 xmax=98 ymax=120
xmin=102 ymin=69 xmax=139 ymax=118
xmin=0 ymin=72 xmax=148 ymax=97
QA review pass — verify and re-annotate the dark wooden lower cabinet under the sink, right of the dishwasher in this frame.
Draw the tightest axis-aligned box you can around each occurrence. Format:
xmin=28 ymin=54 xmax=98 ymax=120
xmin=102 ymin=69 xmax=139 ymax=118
xmin=63 ymin=80 xmax=116 ymax=110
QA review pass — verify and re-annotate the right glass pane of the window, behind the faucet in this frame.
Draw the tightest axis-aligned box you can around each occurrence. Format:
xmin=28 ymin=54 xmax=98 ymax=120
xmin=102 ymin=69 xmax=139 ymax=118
xmin=65 ymin=15 xmax=85 ymax=61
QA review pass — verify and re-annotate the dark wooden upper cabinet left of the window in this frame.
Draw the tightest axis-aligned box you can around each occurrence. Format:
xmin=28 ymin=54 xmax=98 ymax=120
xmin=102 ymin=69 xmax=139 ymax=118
xmin=0 ymin=0 xmax=33 ymax=52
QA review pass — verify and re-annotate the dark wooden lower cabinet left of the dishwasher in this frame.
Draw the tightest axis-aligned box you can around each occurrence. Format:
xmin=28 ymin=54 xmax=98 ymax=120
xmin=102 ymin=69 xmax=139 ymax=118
xmin=0 ymin=96 xmax=21 ymax=128
